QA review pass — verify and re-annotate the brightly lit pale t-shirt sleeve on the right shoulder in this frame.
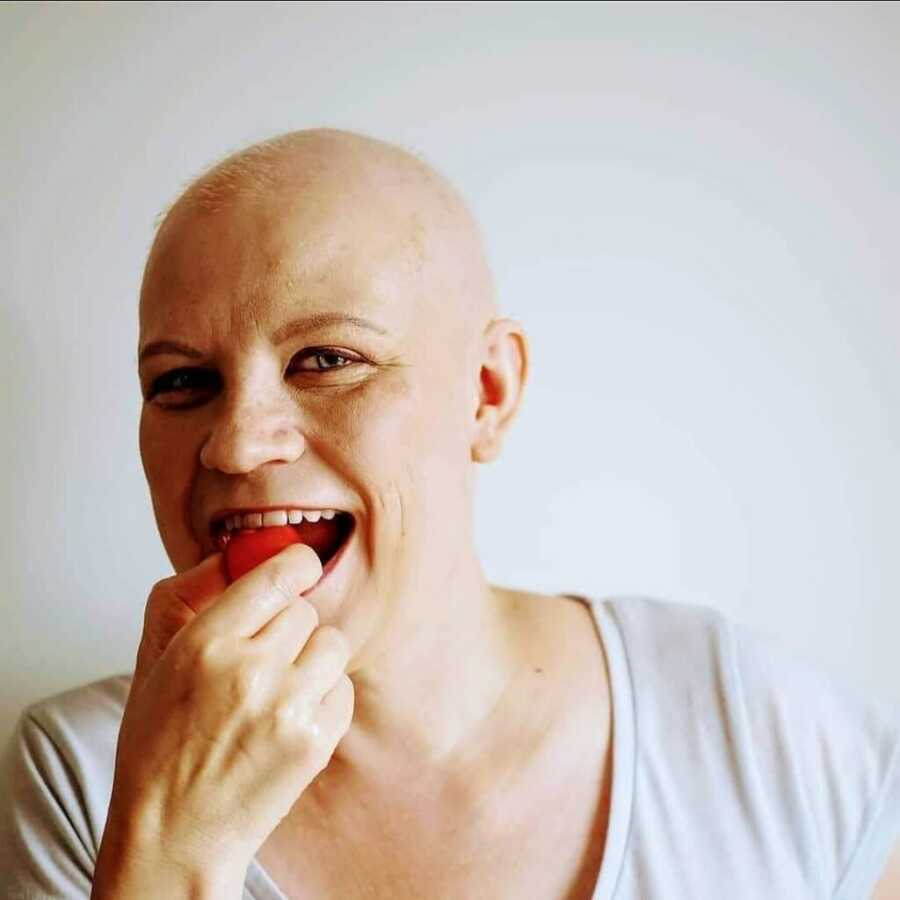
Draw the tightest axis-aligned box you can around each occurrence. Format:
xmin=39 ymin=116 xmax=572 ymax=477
xmin=732 ymin=623 xmax=900 ymax=900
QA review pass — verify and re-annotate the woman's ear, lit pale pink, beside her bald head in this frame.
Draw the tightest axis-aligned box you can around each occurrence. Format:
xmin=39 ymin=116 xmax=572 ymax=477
xmin=471 ymin=318 xmax=529 ymax=463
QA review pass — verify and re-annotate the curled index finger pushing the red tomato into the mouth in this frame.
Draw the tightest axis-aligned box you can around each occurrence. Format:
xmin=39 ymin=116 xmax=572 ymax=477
xmin=195 ymin=544 xmax=322 ymax=638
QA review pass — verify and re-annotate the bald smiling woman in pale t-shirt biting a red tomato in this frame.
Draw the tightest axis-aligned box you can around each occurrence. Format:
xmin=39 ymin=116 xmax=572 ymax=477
xmin=4 ymin=130 xmax=900 ymax=900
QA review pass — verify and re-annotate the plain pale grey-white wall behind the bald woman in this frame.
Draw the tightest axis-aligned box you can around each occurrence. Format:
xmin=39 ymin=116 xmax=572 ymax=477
xmin=0 ymin=2 xmax=900 ymax=740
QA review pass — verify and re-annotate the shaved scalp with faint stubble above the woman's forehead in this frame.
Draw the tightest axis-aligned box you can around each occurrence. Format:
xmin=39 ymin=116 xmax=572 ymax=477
xmin=148 ymin=128 xmax=497 ymax=331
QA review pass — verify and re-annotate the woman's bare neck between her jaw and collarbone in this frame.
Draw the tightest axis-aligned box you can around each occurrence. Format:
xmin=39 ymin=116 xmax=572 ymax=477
xmin=333 ymin=554 xmax=521 ymax=782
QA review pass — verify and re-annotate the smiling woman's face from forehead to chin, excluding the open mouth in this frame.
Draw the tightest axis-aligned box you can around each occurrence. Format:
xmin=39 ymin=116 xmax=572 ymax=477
xmin=140 ymin=181 xmax=479 ymax=648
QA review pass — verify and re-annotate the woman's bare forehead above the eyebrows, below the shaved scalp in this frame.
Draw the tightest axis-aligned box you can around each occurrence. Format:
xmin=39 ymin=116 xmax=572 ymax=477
xmin=140 ymin=183 xmax=428 ymax=339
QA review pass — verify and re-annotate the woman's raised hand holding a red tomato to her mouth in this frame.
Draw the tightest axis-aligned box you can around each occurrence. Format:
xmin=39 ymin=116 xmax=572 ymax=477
xmin=110 ymin=544 xmax=353 ymax=871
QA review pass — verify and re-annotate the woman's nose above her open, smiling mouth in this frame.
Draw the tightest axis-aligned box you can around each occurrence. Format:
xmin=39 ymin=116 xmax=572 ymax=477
xmin=200 ymin=393 xmax=306 ymax=475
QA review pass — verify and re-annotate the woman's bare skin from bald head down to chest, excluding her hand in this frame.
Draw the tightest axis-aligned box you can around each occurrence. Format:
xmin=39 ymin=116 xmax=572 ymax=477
xmin=132 ymin=130 xmax=611 ymax=897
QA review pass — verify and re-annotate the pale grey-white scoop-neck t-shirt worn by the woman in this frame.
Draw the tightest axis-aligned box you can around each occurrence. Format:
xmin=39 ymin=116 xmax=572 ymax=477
xmin=0 ymin=597 xmax=900 ymax=900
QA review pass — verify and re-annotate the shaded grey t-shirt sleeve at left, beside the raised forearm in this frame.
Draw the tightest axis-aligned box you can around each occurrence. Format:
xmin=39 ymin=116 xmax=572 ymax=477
xmin=0 ymin=710 xmax=94 ymax=900
